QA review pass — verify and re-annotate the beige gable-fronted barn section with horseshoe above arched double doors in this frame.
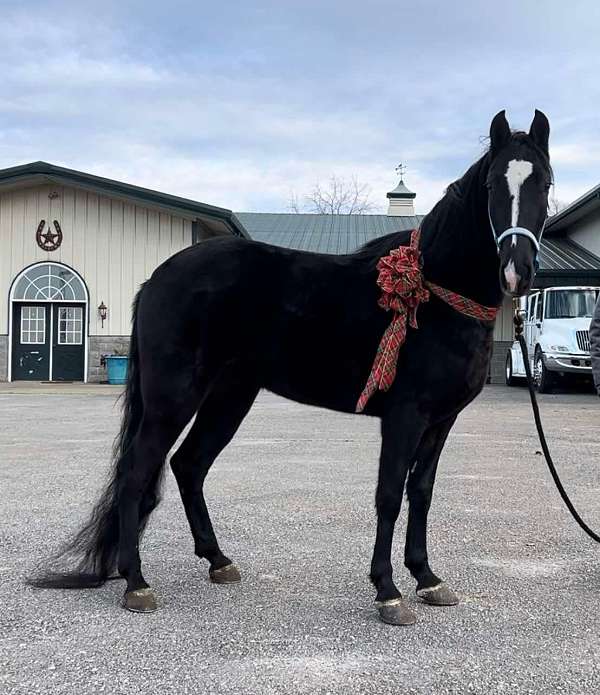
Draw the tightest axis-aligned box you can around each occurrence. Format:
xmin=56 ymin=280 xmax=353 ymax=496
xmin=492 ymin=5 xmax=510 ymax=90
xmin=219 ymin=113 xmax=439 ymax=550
xmin=0 ymin=162 xmax=246 ymax=381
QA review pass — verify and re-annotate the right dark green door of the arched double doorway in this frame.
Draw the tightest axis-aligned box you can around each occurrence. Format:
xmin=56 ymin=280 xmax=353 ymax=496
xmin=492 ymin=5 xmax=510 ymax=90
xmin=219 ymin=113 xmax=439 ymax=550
xmin=52 ymin=303 xmax=86 ymax=381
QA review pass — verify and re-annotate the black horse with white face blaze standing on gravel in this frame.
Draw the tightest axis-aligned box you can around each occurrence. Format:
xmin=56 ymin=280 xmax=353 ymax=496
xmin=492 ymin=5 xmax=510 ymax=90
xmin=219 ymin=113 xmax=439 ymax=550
xmin=31 ymin=111 xmax=552 ymax=624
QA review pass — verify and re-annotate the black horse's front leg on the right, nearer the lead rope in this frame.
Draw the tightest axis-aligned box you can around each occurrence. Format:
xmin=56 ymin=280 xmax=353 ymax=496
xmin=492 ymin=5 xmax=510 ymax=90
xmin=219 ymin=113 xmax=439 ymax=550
xmin=404 ymin=417 xmax=458 ymax=606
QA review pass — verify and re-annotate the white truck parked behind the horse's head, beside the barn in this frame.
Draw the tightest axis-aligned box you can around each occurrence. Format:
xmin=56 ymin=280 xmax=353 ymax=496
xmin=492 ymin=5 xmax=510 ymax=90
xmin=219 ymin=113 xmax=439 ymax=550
xmin=506 ymin=287 xmax=600 ymax=393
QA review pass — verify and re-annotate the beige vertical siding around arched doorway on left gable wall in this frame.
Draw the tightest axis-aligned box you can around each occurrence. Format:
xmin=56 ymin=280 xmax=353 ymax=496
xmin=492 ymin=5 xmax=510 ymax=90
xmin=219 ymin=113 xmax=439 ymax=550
xmin=0 ymin=185 xmax=192 ymax=336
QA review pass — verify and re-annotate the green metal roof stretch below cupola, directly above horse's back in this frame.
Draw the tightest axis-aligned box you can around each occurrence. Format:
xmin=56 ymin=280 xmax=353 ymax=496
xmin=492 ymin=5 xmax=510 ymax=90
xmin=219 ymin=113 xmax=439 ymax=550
xmin=236 ymin=212 xmax=423 ymax=254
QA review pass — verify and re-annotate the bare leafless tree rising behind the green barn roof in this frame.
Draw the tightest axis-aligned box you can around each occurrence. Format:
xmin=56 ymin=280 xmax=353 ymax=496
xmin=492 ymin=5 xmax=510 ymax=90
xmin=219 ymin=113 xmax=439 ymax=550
xmin=288 ymin=174 xmax=375 ymax=215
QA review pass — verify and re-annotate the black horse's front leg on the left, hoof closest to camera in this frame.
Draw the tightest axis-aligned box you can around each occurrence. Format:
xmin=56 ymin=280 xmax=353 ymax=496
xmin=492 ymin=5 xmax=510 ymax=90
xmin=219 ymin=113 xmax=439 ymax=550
xmin=371 ymin=404 xmax=426 ymax=625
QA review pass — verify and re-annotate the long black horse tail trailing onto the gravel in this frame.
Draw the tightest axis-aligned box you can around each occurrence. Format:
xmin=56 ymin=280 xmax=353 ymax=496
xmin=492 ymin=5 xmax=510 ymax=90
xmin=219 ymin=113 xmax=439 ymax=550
xmin=27 ymin=286 xmax=162 ymax=589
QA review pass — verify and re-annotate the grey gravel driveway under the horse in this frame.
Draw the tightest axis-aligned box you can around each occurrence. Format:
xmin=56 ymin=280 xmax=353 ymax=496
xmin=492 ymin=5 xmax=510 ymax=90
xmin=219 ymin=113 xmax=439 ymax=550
xmin=0 ymin=385 xmax=600 ymax=695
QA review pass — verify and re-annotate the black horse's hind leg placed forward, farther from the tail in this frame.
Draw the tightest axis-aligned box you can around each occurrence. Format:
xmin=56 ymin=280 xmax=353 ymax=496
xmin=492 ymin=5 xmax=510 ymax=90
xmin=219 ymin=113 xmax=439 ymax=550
xmin=171 ymin=371 xmax=259 ymax=584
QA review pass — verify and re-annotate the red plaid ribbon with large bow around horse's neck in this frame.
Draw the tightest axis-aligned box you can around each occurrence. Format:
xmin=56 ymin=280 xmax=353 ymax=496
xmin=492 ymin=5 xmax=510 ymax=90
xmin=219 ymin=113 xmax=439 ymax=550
xmin=356 ymin=229 xmax=498 ymax=413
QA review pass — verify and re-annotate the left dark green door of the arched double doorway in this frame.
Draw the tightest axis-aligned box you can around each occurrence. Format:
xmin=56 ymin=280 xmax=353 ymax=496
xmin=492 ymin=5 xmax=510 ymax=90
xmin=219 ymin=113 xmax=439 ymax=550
xmin=12 ymin=304 xmax=51 ymax=381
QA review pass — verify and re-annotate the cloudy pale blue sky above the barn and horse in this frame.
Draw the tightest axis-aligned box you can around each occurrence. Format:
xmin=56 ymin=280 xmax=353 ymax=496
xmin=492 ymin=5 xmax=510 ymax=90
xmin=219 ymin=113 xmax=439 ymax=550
xmin=0 ymin=0 xmax=600 ymax=212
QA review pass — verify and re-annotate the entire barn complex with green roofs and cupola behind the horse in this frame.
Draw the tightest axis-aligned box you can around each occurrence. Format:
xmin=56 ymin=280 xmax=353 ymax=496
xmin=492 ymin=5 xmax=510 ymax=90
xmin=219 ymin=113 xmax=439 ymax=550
xmin=0 ymin=162 xmax=600 ymax=382
